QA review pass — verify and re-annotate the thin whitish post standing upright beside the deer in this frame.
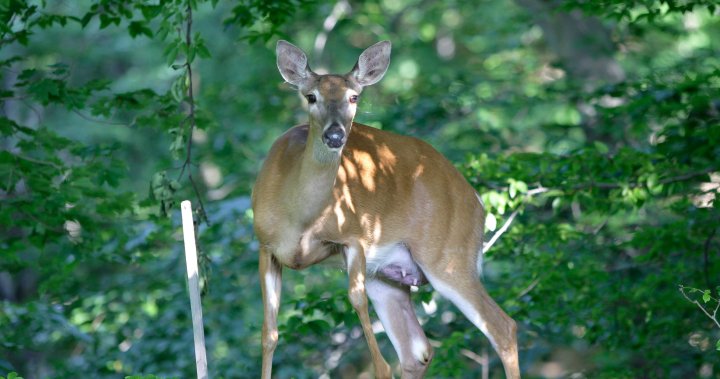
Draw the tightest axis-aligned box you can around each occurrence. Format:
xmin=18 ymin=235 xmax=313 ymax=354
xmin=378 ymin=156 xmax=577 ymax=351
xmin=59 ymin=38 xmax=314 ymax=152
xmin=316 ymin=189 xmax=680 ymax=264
xmin=180 ymin=200 xmax=208 ymax=379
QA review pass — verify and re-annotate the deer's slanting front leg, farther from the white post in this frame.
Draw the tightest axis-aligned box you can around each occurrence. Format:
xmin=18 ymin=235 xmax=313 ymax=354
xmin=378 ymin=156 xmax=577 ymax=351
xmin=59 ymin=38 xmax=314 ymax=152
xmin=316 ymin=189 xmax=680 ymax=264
xmin=345 ymin=244 xmax=392 ymax=379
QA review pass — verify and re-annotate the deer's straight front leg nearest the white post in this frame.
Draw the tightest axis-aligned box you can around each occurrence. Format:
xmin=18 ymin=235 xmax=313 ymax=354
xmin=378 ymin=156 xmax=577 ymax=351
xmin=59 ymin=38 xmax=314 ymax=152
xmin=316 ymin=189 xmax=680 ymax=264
xmin=259 ymin=247 xmax=282 ymax=379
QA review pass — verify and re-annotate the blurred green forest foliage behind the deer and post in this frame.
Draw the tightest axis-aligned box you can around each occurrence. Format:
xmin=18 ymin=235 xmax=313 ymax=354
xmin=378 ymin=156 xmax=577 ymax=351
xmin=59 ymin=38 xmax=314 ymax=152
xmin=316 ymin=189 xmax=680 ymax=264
xmin=0 ymin=0 xmax=720 ymax=379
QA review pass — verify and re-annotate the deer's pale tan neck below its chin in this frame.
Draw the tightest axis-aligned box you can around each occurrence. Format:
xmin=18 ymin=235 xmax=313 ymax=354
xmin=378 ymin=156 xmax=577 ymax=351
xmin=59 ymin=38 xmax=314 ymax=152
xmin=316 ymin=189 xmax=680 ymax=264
xmin=296 ymin=128 xmax=342 ymax=223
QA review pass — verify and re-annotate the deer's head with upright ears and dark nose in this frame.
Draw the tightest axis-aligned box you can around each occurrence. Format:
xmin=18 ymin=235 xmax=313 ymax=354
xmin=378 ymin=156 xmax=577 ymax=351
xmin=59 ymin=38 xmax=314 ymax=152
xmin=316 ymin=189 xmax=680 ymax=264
xmin=277 ymin=40 xmax=390 ymax=155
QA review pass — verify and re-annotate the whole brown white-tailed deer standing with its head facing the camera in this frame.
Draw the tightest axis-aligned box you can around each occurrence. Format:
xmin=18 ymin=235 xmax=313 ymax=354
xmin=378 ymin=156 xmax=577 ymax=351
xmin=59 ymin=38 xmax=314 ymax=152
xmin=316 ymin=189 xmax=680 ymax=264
xmin=252 ymin=41 xmax=520 ymax=379
